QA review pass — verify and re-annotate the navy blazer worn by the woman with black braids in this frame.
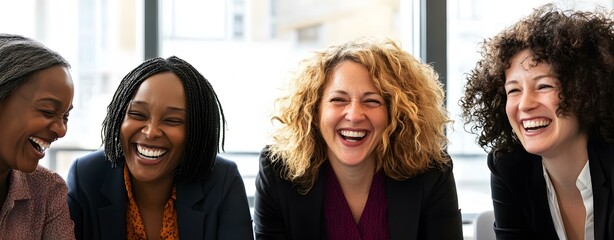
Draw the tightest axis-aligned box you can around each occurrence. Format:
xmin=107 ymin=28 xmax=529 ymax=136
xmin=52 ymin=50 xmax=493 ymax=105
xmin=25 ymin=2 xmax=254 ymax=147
xmin=67 ymin=150 xmax=253 ymax=240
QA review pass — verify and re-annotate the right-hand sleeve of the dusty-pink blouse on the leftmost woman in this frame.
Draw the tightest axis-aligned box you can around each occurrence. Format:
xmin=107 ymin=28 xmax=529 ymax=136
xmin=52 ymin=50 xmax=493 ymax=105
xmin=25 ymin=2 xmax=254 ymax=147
xmin=42 ymin=173 xmax=75 ymax=239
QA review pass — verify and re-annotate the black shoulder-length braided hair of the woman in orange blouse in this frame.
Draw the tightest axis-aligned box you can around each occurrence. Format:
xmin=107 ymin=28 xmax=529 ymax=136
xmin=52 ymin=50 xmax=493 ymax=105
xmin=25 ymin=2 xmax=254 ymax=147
xmin=102 ymin=56 xmax=226 ymax=183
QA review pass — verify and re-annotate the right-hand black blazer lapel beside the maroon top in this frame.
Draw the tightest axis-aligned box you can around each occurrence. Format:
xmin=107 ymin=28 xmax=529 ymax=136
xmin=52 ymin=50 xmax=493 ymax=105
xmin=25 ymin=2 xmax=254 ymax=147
xmin=384 ymin=177 xmax=422 ymax=239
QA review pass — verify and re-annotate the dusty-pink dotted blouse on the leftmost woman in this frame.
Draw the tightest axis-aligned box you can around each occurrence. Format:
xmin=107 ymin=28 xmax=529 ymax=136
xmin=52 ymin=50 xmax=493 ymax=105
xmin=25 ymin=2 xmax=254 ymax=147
xmin=0 ymin=166 xmax=75 ymax=240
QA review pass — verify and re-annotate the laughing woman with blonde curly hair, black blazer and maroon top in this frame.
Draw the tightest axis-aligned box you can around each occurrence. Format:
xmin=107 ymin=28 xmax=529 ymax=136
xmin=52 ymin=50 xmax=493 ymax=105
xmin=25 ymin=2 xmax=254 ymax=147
xmin=254 ymin=38 xmax=462 ymax=239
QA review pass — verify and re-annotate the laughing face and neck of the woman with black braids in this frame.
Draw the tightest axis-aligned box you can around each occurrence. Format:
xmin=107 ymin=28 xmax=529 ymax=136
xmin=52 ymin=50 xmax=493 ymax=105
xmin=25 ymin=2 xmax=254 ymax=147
xmin=120 ymin=72 xmax=186 ymax=238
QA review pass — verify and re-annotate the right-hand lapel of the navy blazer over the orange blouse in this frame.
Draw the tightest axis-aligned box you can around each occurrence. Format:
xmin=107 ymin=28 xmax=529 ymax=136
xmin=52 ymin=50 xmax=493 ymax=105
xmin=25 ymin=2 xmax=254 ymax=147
xmin=175 ymin=184 xmax=205 ymax=239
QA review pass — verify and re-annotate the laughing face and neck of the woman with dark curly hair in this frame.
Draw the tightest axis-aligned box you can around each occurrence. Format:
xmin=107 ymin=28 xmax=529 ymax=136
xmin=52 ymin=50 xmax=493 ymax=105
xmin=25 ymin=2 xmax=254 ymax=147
xmin=505 ymin=50 xmax=587 ymax=157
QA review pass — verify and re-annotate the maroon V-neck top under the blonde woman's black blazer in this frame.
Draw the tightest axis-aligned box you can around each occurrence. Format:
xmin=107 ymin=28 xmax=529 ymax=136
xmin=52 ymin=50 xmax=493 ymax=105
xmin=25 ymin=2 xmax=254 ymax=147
xmin=324 ymin=168 xmax=389 ymax=240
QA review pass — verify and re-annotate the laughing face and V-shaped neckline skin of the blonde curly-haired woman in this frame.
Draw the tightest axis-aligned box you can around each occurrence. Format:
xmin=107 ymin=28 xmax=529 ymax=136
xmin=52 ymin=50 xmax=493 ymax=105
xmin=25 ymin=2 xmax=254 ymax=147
xmin=318 ymin=61 xmax=388 ymax=223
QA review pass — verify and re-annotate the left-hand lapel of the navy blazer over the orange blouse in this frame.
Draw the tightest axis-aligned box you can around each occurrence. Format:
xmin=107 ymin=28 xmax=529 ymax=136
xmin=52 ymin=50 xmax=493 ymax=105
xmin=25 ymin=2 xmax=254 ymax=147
xmin=98 ymin=166 xmax=128 ymax=239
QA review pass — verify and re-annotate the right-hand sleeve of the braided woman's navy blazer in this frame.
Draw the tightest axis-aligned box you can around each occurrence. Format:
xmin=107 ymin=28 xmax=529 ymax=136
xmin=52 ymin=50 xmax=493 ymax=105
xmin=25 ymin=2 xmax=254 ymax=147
xmin=218 ymin=159 xmax=254 ymax=240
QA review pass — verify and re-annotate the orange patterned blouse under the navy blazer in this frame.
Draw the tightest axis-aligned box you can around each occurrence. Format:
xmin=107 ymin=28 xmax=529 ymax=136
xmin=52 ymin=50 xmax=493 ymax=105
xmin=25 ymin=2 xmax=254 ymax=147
xmin=124 ymin=166 xmax=179 ymax=240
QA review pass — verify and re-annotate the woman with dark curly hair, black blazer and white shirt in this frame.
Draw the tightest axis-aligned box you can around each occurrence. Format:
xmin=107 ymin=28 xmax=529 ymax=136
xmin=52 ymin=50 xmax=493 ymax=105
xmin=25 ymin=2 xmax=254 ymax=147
xmin=460 ymin=4 xmax=614 ymax=239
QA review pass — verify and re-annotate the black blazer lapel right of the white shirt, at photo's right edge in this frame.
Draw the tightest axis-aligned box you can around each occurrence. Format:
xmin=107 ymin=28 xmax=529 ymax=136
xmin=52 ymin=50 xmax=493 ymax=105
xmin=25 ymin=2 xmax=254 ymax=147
xmin=588 ymin=137 xmax=614 ymax=239
